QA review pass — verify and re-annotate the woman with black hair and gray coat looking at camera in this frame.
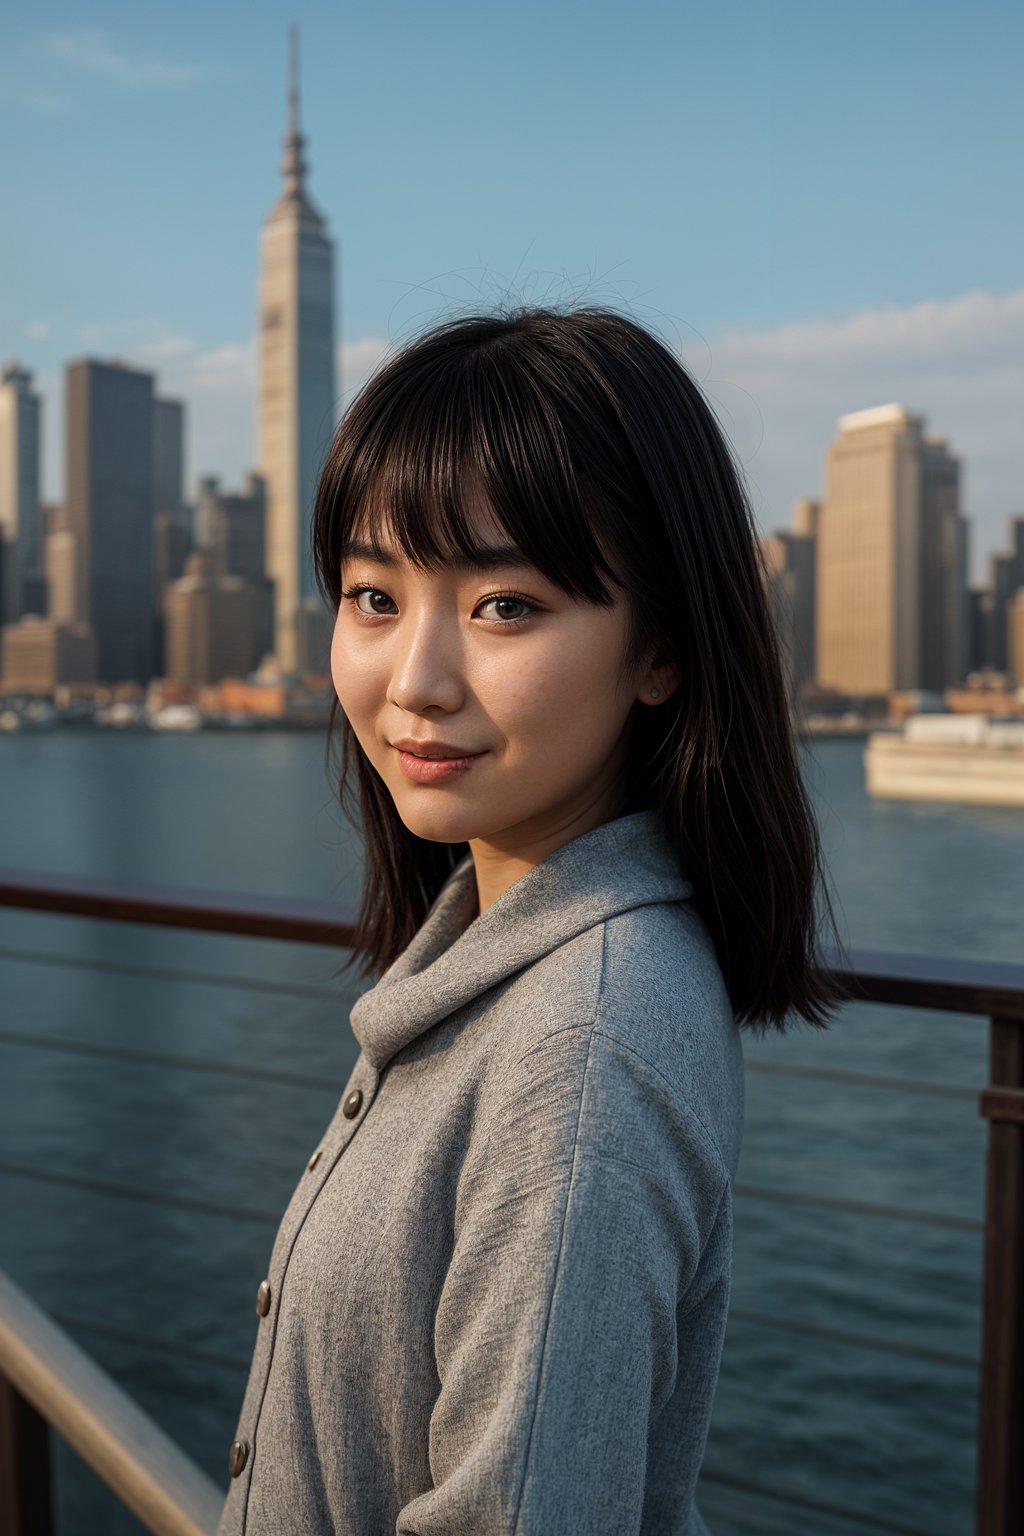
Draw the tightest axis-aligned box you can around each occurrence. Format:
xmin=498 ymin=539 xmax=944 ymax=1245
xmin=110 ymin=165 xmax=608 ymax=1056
xmin=220 ymin=309 xmax=837 ymax=1536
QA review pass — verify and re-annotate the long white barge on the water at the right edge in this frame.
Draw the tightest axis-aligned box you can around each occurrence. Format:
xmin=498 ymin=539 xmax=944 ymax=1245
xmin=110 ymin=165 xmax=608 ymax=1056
xmin=864 ymin=714 xmax=1024 ymax=808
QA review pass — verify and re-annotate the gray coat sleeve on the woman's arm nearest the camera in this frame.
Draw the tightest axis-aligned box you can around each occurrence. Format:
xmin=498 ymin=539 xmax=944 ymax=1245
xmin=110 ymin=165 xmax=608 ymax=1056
xmin=396 ymin=1026 xmax=729 ymax=1536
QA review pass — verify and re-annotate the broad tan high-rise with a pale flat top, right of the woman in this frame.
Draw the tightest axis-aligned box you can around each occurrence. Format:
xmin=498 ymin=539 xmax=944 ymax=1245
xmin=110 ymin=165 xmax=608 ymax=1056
xmin=815 ymin=406 xmax=967 ymax=694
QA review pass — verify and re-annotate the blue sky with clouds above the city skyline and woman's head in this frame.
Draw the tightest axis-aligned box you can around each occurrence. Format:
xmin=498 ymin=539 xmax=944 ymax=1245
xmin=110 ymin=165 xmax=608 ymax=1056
xmin=0 ymin=0 xmax=1024 ymax=573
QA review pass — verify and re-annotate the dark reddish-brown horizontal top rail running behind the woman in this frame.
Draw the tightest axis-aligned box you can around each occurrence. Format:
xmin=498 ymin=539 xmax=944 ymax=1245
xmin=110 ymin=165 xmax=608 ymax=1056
xmin=0 ymin=868 xmax=1024 ymax=1021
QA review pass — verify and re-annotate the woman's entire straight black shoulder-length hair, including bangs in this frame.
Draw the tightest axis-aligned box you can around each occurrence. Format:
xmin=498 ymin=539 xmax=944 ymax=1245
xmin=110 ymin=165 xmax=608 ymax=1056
xmin=312 ymin=307 xmax=841 ymax=1029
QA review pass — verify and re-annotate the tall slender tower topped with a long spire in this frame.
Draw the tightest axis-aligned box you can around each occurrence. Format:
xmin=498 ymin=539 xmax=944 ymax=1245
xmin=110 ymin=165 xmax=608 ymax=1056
xmin=258 ymin=25 xmax=336 ymax=673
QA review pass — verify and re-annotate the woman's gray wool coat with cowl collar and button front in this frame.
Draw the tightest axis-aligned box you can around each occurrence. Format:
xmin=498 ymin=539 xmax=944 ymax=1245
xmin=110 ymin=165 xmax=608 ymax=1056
xmin=218 ymin=811 xmax=743 ymax=1536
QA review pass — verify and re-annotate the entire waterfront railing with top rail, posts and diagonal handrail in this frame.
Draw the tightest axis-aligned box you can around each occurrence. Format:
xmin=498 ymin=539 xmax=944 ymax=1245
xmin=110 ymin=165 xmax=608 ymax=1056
xmin=0 ymin=869 xmax=1024 ymax=1536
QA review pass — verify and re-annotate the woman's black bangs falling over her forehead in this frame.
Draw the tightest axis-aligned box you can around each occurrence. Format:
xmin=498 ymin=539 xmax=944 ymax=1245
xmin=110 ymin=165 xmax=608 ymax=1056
xmin=315 ymin=347 xmax=622 ymax=607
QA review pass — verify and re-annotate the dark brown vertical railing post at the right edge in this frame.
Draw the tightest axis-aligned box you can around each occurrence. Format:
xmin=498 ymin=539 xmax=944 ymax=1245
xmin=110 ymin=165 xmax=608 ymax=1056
xmin=975 ymin=1017 xmax=1024 ymax=1536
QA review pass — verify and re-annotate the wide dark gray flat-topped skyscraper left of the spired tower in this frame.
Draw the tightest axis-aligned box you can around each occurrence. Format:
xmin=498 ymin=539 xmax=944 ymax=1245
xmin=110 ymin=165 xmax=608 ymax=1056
xmin=64 ymin=358 xmax=155 ymax=682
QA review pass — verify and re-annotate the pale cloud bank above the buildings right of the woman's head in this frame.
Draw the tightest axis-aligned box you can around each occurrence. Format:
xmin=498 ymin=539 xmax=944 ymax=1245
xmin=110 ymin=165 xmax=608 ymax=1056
xmin=680 ymin=289 xmax=1024 ymax=579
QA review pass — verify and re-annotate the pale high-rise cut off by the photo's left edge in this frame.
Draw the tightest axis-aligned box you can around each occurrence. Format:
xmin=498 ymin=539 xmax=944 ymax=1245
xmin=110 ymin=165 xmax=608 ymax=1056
xmin=0 ymin=362 xmax=43 ymax=624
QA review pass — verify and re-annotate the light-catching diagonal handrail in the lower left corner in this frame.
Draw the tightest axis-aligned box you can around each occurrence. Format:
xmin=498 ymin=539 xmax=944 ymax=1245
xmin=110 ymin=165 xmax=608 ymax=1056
xmin=0 ymin=1270 xmax=224 ymax=1536
